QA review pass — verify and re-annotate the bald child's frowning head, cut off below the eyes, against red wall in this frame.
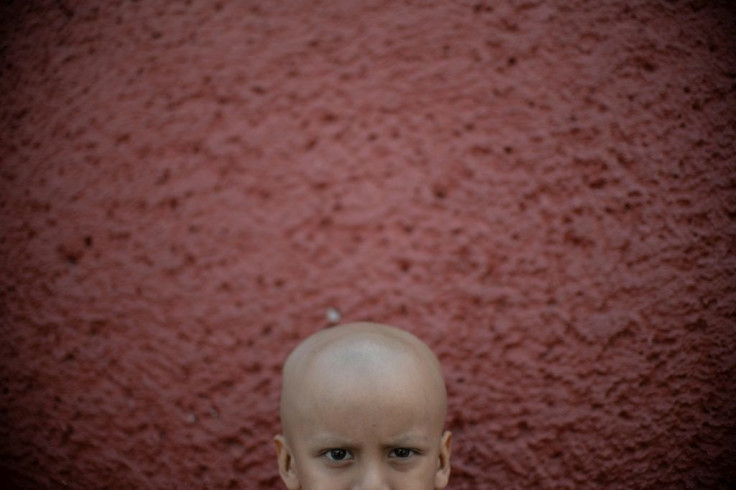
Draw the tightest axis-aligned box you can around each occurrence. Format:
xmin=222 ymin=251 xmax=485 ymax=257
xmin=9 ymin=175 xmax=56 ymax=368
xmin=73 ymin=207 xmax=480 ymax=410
xmin=274 ymin=323 xmax=451 ymax=490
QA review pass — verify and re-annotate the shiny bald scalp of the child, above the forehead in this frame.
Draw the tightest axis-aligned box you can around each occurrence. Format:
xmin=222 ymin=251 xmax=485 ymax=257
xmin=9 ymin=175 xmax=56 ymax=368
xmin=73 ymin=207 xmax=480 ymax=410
xmin=280 ymin=322 xmax=447 ymax=439
